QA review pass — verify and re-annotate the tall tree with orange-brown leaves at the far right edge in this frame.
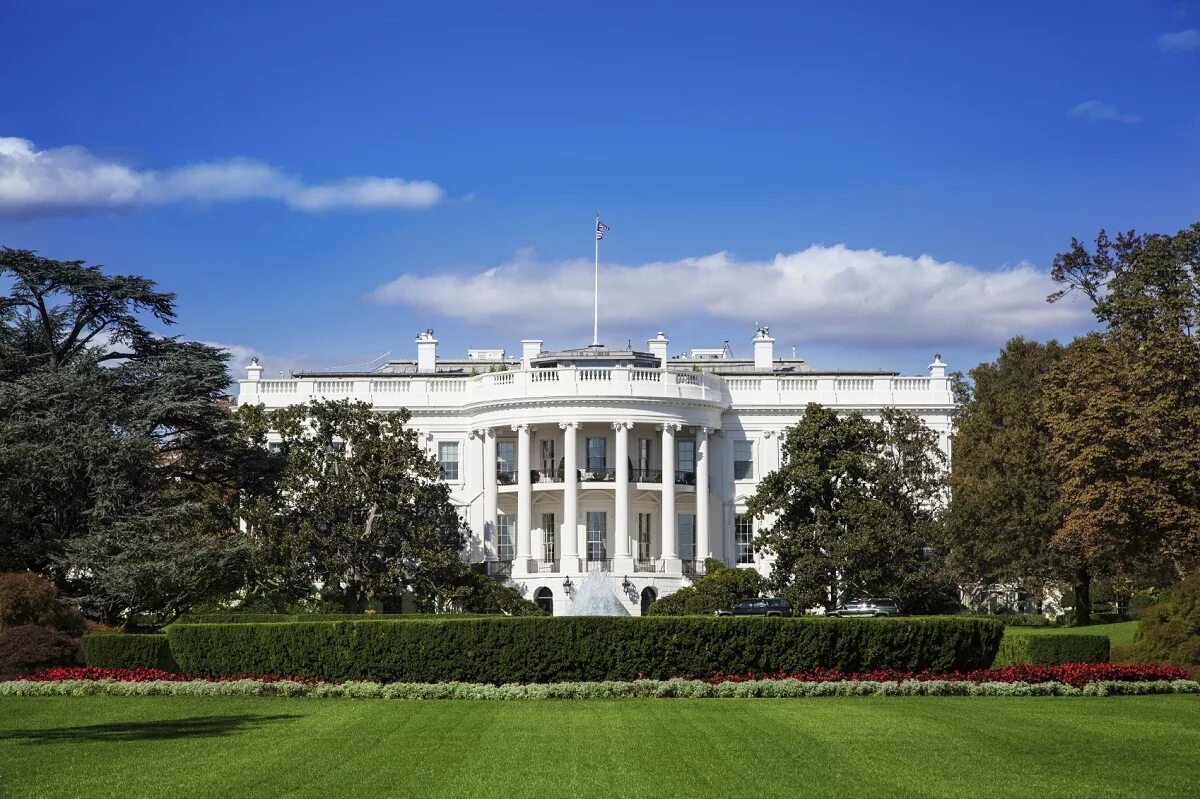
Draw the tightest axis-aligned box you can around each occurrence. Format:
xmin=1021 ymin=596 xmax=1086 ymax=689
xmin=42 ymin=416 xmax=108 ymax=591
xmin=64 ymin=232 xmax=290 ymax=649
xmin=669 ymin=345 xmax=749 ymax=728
xmin=1043 ymin=224 xmax=1200 ymax=624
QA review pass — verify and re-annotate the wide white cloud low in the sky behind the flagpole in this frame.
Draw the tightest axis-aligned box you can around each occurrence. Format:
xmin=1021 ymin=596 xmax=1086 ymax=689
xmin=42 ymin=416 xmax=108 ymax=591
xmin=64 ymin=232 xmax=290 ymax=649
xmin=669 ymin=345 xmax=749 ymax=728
xmin=368 ymin=245 xmax=1090 ymax=346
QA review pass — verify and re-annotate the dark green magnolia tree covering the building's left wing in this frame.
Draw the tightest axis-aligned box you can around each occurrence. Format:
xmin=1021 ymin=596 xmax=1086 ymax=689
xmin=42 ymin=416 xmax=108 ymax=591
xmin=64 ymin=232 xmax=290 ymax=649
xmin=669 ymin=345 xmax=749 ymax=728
xmin=241 ymin=401 xmax=478 ymax=609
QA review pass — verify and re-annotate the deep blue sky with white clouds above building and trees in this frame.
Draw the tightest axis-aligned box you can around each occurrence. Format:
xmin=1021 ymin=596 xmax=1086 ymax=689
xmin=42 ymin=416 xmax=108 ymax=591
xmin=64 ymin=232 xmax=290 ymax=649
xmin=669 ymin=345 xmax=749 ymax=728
xmin=0 ymin=2 xmax=1200 ymax=373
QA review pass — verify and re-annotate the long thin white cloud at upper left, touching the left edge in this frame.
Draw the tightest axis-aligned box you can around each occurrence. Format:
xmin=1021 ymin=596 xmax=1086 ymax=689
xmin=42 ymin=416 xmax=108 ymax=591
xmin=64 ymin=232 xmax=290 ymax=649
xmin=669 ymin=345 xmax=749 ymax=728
xmin=0 ymin=137 xmax=445 ymax=215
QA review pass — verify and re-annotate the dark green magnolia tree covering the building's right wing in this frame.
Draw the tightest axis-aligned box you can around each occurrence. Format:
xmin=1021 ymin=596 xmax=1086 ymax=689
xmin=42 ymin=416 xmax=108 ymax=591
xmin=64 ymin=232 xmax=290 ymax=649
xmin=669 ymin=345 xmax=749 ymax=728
xmin=748 ymin=404 xmax=946 ymax=609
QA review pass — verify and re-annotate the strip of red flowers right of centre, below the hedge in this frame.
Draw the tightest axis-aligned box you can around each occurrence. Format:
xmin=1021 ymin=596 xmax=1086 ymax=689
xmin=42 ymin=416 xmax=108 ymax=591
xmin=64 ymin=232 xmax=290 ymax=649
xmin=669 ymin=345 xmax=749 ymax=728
xmin=708 ymin=663 xmax=1188 ymax=687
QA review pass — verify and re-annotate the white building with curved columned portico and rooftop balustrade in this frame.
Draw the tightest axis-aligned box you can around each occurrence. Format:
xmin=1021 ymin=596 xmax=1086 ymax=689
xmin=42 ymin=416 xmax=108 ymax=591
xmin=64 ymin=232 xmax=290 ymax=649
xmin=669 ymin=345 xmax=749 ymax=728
xmin=238 ymin=329 xmax=955 ymax=615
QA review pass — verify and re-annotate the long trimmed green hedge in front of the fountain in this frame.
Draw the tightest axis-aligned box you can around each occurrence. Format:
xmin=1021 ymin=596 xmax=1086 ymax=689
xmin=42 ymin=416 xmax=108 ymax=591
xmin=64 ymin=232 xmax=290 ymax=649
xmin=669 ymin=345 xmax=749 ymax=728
xmin=167 ymin=617 xmax=1003 ymax=683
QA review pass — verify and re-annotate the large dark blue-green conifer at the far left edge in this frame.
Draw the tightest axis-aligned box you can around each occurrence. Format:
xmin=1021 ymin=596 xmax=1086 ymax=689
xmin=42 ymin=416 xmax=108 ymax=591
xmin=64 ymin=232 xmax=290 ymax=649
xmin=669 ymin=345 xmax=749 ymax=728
xmin=0 ymin=248 xmax=252 ymax=623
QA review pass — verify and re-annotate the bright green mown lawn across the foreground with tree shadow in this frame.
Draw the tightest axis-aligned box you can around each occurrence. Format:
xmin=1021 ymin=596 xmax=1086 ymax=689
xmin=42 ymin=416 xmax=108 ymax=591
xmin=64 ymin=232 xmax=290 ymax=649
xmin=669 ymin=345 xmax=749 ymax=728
xmin=0 ymin=696 xmax=1200 ymax=799
